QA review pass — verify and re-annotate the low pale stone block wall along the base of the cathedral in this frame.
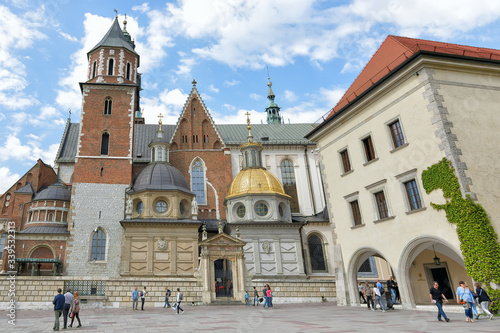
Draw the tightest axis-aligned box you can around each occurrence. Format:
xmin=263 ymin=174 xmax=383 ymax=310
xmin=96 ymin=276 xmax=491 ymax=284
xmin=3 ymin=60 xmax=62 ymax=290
xmin=0 ymin=276 xmax=335 ymax=310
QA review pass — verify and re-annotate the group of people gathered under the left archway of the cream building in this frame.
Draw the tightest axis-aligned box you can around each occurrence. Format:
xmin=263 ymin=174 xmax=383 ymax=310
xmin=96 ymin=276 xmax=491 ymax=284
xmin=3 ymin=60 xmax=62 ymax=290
xmin=358 ymin=276 xmax=399 ymax=312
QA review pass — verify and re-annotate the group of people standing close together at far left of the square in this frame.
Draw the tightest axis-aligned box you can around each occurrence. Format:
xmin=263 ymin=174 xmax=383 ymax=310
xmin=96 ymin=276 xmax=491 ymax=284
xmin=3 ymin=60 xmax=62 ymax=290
xmin=52 ymin=288 xmax=82 ymax=331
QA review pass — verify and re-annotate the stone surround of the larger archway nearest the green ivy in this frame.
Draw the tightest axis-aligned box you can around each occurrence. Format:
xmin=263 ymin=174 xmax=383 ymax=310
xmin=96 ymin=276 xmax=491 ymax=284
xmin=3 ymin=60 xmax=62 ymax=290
xmin=398 ymin=235 xmax=465 ymax=308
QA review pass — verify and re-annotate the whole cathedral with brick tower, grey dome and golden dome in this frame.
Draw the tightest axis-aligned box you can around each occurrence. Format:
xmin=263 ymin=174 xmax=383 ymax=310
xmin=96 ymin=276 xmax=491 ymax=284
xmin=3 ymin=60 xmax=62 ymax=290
xmin=2 ymin=17 xmax=335 ymax=306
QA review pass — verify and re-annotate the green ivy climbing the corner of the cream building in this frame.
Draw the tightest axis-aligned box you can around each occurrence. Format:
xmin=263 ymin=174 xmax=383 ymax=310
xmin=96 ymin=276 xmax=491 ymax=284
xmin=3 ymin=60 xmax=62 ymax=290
xmin=422 ymin=158 xmax=500 ymax=311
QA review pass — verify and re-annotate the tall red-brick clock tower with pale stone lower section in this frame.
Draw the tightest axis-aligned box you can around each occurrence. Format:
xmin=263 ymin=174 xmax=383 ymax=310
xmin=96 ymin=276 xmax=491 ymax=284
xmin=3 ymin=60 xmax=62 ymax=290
xmin=66 ymin=17 xmax=140 ymax=276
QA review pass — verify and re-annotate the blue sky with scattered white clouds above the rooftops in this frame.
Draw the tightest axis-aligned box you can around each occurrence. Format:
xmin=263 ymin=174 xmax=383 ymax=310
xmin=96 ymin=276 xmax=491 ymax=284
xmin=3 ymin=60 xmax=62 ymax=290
xmin=0 ymin=0 xmax=500 ymax=193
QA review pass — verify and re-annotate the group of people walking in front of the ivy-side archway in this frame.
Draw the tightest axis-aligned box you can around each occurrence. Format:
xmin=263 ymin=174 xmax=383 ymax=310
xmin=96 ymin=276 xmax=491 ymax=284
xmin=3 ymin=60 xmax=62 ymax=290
xmin=430 ymin=281 xmax=493 ymax=323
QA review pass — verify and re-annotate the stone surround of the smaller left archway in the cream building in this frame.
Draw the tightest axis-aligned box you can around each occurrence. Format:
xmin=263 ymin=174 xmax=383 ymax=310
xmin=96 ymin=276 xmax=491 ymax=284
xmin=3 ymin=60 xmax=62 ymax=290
xmin=346 ymin=247 xmax=398 ymax=306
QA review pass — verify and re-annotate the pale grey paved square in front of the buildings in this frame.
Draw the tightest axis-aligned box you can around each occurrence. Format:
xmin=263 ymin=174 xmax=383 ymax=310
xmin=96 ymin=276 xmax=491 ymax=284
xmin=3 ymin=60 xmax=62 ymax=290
xmin=0 ymin=303 xmax=500 ymax=333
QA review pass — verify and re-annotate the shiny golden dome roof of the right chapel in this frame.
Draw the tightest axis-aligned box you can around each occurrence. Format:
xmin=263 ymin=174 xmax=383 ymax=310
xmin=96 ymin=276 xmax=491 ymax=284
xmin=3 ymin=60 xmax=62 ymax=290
xmin=226 ymin=168 xmax=289 ymax=199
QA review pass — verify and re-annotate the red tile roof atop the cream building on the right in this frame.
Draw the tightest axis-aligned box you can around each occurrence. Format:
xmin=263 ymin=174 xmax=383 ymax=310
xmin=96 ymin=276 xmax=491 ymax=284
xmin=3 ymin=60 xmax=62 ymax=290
xmin=328 ymin=35 xmax=500 ymax=117
